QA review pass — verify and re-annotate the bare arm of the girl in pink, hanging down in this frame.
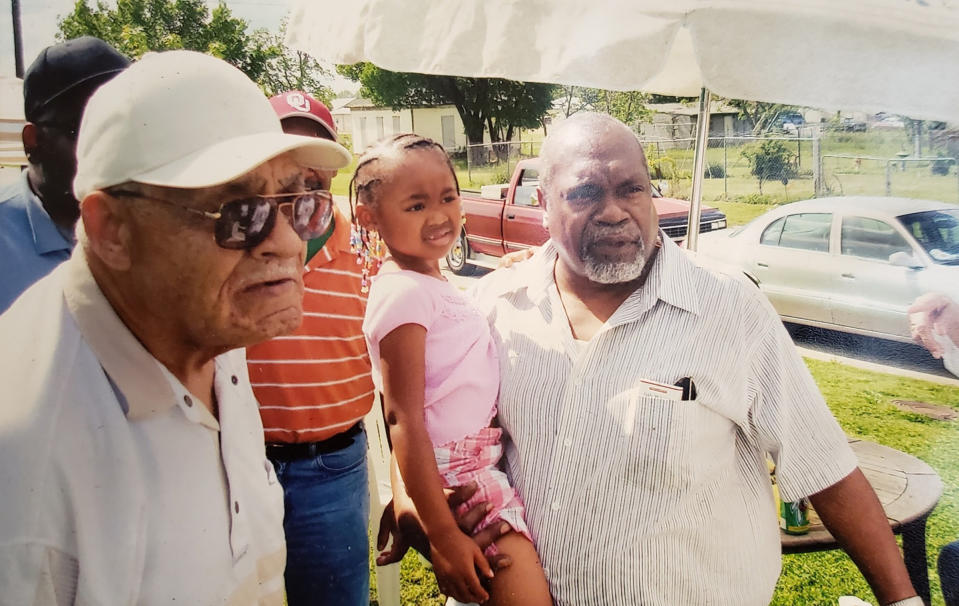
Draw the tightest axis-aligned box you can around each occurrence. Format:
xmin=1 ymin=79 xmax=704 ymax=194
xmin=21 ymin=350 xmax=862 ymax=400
xmin=380 ymin=324 xmax=493 ymax=603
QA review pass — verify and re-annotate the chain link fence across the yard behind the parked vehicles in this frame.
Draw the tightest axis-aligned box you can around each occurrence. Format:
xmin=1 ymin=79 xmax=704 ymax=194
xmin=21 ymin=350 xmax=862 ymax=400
xmin=464 ymin=128 xmax=959 ymax=204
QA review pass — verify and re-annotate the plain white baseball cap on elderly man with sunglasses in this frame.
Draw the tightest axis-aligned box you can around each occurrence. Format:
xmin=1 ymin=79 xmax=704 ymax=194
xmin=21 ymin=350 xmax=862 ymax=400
xmin=73 ymin=50 xmax=351 ymax=200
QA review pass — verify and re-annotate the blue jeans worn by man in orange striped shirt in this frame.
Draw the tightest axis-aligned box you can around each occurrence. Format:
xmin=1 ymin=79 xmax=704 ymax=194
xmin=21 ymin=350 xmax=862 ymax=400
xmin=273 ymin=431 xmax=370 ymax=606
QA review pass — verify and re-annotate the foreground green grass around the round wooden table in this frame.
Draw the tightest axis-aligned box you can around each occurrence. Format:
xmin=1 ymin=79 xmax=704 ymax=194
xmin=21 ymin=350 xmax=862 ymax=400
xmin=371 ymin=359 xmax=959 ymax=606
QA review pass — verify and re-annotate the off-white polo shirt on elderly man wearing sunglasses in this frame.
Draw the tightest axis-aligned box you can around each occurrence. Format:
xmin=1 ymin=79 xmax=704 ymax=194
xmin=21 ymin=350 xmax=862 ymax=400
xmin=0 ymin=247 xmax=286 ymax=606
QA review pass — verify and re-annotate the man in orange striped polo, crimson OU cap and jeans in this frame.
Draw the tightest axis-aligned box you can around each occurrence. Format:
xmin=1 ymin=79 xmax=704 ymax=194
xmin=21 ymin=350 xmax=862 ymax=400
xmin=247 ymin=91 xmax=373 ymax=606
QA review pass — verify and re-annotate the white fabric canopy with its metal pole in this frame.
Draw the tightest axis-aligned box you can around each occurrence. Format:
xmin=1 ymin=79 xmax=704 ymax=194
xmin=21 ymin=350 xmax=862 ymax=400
xmin=287 ymin=0 xmax=959 ymax=247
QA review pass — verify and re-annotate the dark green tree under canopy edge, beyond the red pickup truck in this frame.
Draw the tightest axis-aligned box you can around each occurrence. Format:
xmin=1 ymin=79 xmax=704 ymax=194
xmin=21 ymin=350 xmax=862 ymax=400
xmin=337 ymin=63 xmax=553 ymax=158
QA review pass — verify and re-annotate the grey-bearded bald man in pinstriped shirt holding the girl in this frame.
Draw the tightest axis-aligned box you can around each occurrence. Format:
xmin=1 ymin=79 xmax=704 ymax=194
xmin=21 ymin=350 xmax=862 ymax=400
xmin=397 ymin=114 xmax=922 ymax=606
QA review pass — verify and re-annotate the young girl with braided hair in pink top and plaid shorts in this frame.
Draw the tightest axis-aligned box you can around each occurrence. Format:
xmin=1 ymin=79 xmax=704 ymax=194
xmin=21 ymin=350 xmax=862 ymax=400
xmin=351 ymin=134 xmax=552 ymax=605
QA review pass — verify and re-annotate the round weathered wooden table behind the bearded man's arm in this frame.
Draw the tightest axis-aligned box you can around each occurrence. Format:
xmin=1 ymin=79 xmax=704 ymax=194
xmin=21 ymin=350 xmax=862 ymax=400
xmin=781 ymin=439 xmax=942 ymax=604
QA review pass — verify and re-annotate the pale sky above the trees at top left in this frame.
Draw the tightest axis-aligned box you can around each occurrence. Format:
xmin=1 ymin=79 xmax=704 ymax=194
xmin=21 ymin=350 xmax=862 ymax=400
xmin=0 ymin=0 xmax=356 ymax=89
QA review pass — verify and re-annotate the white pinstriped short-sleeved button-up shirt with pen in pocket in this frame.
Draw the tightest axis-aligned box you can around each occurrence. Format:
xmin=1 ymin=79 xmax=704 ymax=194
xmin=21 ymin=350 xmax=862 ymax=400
xmin=476 ymin=237 xmax=856 ymax=606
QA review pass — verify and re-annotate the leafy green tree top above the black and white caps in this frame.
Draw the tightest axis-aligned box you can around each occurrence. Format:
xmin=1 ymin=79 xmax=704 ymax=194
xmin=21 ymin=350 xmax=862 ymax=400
xmin=57 ymin=0 xmax=283 ymax=82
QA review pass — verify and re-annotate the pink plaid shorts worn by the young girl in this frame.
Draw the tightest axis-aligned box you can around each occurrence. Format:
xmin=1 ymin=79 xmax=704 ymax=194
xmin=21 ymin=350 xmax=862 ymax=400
xmin=433 ymin=427 xmax=533 ymax=555
